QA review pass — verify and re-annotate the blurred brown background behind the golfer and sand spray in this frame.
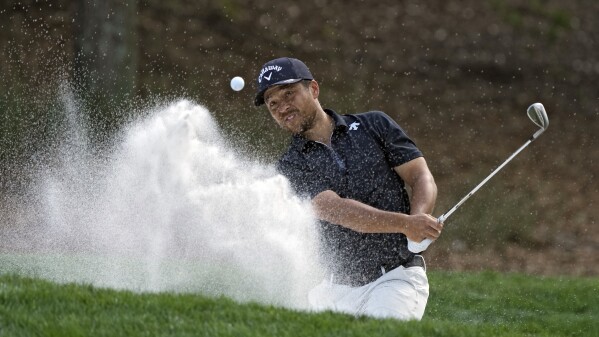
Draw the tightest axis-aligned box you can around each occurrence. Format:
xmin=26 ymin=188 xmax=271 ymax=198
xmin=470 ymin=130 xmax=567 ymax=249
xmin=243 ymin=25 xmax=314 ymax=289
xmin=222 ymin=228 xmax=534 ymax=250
xmin=0 ymin=0 xmax=599 ymax=275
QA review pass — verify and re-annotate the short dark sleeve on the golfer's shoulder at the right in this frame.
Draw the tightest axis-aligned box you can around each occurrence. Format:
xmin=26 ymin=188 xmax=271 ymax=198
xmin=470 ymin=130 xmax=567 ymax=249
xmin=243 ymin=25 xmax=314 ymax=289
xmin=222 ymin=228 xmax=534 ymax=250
xmin=372 ymin=111 xmax=423 ymax=167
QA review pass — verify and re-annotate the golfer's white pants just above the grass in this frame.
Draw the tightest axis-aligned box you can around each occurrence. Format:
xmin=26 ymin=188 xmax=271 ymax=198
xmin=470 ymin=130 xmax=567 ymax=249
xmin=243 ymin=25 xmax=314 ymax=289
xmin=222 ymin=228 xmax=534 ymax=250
xmin=308 ymin=266 xmax=428 ymax=320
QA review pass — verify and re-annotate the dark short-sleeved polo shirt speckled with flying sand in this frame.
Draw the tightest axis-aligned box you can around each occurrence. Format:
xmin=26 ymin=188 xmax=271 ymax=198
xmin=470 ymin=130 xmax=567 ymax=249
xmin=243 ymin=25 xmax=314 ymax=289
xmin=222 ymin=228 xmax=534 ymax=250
xmin=278 ymin=109 xmax=422 ymax=285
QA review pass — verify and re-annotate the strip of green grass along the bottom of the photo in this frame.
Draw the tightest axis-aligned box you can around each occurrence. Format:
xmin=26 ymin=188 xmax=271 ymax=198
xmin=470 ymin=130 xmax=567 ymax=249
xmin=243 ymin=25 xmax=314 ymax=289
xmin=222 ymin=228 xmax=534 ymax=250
xmin=0 ymin=272 xmax=599 ymax=336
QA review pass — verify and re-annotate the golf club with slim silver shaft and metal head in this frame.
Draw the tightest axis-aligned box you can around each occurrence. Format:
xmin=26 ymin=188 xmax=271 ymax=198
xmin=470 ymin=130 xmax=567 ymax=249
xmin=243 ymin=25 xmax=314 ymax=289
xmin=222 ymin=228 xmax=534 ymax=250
xmin=408 ymin=103 xmax=549 ymax=253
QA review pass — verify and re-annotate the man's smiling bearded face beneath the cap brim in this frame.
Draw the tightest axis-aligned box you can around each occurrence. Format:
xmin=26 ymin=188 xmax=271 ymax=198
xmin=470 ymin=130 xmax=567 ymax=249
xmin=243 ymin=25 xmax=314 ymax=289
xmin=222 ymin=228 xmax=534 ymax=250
xmin=264 ymin=81 xmax=317 ymax=134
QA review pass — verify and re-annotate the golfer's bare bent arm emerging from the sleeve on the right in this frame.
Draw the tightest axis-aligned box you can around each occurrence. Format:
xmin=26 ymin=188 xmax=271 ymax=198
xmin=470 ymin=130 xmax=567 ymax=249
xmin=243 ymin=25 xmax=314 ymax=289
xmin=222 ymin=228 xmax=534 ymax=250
xmin=394 ymin=157 xmax=437 ymax=214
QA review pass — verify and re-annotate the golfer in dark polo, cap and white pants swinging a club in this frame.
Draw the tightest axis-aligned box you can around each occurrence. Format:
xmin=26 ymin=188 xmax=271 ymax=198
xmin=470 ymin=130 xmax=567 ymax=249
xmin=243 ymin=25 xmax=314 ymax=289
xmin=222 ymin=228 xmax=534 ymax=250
xmin=255 ymin=57 xmax=442 ymax=320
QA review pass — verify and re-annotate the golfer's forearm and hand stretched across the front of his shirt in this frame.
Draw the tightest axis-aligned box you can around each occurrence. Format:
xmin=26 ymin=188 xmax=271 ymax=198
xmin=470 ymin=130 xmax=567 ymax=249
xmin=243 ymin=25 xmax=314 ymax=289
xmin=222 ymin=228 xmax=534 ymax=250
xmin=312 ymin=190 xmax=443 ymax=242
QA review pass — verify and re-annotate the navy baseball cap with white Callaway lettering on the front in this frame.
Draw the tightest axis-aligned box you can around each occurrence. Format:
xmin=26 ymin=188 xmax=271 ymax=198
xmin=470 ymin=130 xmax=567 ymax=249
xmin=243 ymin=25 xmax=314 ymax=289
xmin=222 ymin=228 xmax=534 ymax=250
xmin=254 ymin=57 xmax=314 ymax=105
